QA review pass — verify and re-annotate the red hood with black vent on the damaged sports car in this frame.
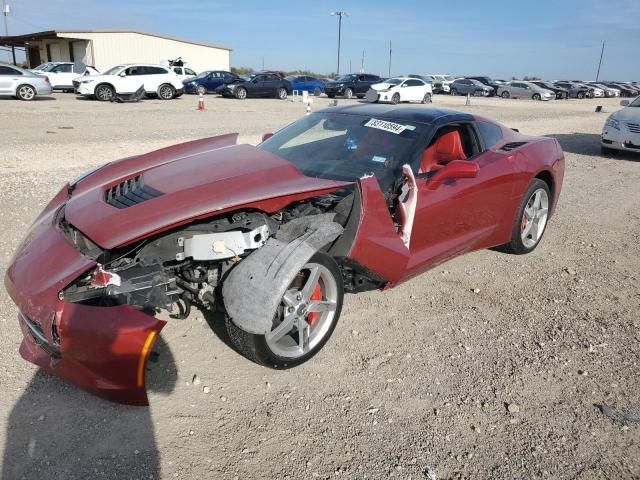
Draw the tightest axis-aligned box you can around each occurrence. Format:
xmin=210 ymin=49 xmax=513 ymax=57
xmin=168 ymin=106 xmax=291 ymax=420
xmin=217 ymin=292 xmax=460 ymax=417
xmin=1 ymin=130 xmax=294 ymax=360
xmin=64 ymin=134 xmax=351 ymax=250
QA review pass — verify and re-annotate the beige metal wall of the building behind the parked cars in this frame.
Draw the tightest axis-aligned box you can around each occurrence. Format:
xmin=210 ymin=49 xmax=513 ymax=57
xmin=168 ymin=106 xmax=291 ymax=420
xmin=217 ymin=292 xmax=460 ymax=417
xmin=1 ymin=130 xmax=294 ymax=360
xmin=58 ymin=32 xmax=231 ymax=72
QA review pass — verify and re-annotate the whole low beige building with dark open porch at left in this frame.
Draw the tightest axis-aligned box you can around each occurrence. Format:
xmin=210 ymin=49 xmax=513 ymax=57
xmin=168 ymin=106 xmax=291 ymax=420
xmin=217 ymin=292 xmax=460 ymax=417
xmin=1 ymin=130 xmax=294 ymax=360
xmin=0 ymin=30 xmax=231 ymax=72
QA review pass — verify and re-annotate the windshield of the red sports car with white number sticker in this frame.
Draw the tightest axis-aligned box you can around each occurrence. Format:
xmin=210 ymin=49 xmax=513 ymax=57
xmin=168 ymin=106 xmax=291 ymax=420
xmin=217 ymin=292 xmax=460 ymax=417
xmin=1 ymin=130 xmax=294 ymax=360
xmin=259 ymin=113 xmax=430 ymax=193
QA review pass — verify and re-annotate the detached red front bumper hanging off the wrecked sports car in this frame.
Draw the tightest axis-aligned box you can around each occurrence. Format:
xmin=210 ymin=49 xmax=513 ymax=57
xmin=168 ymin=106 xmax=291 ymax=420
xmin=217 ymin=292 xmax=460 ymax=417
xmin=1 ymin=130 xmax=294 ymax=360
xmin=5 ymin=188 xmax=165 ymax=405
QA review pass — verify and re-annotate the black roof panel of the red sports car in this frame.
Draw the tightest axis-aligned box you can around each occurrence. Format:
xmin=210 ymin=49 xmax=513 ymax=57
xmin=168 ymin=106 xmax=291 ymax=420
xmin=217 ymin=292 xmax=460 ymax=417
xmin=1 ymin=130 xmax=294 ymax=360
xmin=318 ymin=103 xmax=474 ymax=124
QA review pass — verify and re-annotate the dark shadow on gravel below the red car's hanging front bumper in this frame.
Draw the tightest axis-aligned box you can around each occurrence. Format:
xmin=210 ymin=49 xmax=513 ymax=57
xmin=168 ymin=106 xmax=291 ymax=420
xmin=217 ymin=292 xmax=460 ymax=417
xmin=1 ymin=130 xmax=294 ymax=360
xmin=1 ymin=337 xmax=177 ymax=480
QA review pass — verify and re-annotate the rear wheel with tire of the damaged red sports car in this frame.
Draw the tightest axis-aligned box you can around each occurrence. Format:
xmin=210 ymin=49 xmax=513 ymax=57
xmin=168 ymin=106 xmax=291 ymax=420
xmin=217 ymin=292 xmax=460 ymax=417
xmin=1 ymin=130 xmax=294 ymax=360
xmin=499 ymin=178 xmax=553 ymax=255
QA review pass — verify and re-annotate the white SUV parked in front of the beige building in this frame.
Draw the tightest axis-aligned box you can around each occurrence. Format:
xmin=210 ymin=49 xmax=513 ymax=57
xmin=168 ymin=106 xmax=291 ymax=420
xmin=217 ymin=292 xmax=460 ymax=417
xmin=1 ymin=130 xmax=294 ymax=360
xmin=73 ymin=63 xmax=184 ymax=102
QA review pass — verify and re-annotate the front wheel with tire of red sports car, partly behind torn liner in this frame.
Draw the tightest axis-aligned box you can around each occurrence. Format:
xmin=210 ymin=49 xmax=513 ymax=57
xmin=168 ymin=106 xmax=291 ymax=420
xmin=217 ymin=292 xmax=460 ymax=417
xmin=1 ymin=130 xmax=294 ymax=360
xmin=226 ymin=253 xmax=344 ymax=368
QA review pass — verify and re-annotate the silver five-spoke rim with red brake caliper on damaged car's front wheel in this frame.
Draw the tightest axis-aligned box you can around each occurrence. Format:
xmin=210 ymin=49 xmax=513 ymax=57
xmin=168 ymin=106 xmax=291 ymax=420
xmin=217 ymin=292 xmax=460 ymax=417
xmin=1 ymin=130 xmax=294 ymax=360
xmin=265 ymin=262 xmax=338 ymax=360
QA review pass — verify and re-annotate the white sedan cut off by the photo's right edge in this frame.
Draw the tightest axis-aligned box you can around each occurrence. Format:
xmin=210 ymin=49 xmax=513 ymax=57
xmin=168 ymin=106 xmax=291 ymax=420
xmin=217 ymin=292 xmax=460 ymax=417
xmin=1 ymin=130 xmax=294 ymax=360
xmin=600 ymin=97 xmax=640 ymax=153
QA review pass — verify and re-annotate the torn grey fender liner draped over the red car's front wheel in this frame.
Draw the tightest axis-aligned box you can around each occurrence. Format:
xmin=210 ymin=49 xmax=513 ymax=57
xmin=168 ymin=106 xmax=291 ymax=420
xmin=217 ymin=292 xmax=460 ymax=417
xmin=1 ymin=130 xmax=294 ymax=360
xmin=222 ymin=219 xmax=343 ymax=335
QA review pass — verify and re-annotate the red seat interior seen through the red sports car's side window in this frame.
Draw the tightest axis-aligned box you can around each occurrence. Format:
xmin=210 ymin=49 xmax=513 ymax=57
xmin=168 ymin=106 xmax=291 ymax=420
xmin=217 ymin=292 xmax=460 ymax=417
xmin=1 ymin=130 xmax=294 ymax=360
xmin=418 ymin=124 xmax=479 ymax=174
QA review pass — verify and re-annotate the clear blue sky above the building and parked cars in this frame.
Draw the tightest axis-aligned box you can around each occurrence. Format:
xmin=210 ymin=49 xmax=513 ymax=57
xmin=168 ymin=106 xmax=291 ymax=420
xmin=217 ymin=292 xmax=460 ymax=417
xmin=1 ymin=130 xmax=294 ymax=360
xmin=8 ymin=0 xmax=640 ymax=80
